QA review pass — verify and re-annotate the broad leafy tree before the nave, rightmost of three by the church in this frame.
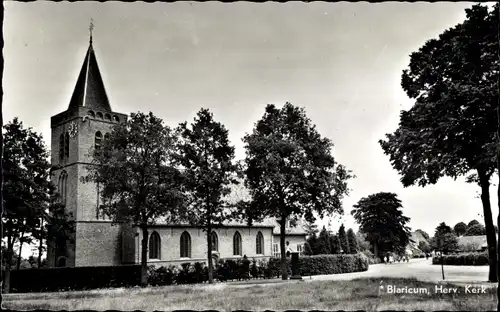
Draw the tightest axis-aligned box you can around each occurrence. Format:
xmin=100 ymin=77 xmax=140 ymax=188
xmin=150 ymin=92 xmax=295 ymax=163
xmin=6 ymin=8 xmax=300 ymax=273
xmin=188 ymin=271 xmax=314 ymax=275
xmin=243 ymin=103 xmax=352 ymax=279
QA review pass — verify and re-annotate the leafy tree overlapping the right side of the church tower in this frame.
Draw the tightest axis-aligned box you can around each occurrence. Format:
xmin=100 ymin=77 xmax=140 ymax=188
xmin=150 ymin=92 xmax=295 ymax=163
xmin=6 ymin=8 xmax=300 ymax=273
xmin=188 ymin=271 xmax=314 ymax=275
xmin=84 ymin=113 xmax=184 ymax=286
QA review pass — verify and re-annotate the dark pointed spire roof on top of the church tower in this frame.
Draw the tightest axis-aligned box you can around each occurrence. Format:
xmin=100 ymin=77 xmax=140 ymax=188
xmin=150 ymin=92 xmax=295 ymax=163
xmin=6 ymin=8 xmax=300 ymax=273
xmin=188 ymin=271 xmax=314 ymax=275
xmin=68 ymin=37 xmax=111 ymax=112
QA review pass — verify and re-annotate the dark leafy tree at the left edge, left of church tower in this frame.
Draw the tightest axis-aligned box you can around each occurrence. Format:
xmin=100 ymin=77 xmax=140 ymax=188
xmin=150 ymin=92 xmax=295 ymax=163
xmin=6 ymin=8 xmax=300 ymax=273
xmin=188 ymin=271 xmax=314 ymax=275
xmin=2 ymin=118 xmax=51 ymax=292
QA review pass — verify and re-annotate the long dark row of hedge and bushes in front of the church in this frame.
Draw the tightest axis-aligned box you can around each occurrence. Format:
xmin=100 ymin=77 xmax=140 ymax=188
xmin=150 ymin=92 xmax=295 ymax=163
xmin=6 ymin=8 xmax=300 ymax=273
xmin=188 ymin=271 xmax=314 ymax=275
xmin=4 ymin=254 xmax=369 ymax=292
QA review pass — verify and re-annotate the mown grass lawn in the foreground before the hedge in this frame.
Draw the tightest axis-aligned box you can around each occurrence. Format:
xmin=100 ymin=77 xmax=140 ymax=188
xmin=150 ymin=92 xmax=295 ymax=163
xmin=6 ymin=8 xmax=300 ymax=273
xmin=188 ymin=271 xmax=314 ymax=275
xmin=2 ymin=278 xmax=496 ymax=311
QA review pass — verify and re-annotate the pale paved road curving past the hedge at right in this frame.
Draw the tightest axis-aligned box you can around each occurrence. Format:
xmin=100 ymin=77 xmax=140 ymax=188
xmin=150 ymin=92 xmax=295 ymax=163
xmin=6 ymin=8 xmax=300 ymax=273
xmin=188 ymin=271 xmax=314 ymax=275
xmin=303 ymin=259 xmax=489 ymax=283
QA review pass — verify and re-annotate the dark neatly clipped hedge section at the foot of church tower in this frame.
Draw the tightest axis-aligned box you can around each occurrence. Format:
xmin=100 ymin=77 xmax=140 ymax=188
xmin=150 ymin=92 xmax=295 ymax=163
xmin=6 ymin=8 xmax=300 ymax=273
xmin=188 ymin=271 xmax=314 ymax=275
xmin=6 ymin=265 xmax=141 ymax=293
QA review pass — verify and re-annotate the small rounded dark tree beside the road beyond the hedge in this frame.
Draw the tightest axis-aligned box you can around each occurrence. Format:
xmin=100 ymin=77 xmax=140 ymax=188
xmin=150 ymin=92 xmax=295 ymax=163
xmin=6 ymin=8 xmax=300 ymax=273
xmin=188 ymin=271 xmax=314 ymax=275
xmin=351 ymin=192 xmax=411 ymax=257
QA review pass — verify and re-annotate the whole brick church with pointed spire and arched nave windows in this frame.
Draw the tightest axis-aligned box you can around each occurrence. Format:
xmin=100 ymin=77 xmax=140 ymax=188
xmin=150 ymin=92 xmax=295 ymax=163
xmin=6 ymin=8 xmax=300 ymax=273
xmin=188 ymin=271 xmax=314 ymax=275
xmin=47 ymin=33 xmax=306 ymax=267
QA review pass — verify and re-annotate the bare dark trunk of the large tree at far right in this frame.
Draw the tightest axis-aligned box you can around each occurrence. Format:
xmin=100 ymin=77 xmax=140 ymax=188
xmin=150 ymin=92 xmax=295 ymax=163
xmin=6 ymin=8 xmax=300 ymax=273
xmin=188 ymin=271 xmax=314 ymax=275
xmin=478 ymin=170 xmax=498 ymax=282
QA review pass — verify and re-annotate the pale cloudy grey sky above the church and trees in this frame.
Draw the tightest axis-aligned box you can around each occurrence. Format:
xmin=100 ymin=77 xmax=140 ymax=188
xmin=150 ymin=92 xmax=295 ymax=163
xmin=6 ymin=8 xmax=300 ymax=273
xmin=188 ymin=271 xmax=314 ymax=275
xmin=3 ymin=1 xmax=498 ymax=244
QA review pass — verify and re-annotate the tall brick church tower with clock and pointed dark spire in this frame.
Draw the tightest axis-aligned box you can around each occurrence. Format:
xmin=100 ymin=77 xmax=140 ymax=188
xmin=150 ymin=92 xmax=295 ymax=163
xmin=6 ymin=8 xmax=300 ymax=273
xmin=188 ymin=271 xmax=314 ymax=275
xmin=47 ymin=24 xmax=127 ymax=267
